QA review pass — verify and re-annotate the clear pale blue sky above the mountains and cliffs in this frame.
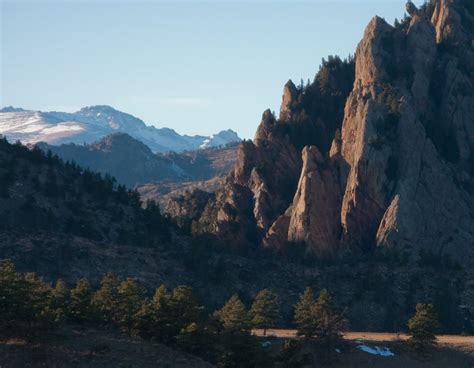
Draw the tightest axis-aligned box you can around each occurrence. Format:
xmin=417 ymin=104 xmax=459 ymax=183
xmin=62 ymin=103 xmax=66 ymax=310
xmin=0 ymin=0 xmax=422 ymax=138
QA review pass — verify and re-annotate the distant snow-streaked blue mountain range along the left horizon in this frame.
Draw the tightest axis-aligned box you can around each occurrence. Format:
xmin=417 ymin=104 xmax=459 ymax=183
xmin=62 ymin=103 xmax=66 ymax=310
xmin=0 ymin=105 xmax=240 ymax=152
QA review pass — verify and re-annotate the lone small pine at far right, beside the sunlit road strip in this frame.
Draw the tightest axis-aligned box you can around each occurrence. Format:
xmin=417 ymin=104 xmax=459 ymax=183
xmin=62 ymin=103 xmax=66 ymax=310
xmin=408 ymin=304 xmax=439 ymax=350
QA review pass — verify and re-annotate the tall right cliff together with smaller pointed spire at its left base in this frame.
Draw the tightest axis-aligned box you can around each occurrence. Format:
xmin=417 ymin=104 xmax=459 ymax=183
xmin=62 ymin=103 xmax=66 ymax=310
xmin=265 ymin=1 xmax=474 ymax=261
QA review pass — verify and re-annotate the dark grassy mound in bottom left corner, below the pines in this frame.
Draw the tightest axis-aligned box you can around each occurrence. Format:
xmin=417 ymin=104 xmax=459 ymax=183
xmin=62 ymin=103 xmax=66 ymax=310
xmin=0 ymin=326 xmax=212 ymax=368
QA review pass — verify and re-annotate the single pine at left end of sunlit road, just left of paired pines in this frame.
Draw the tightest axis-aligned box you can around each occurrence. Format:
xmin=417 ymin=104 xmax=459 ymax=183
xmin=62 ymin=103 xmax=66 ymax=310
xmin=250 ymin=289 xmax=280 ymax=335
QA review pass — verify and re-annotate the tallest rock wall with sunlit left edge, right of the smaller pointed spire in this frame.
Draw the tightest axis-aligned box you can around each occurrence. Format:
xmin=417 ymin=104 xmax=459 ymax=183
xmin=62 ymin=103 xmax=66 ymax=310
xmin=341 ymin=2 xmax=474 ymax=262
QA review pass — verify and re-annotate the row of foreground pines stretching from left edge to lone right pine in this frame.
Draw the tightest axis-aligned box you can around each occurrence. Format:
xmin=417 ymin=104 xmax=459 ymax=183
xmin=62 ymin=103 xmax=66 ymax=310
xmin=0 ymin=260 xmax=439 ymax=368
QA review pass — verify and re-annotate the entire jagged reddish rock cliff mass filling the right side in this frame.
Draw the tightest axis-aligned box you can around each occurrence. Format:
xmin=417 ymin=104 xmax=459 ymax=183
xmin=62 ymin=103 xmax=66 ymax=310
xmin=168 ymin=0 xmax=474 ymax=263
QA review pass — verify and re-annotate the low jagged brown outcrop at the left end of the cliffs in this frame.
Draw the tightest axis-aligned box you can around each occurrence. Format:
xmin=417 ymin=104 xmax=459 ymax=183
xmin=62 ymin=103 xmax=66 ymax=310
xmin=211 ymin=110 xmax=301 ymax=244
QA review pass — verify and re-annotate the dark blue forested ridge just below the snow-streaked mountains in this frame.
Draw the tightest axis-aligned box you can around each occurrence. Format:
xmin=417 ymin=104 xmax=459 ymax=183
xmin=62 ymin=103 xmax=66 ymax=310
xmin=36 ymin=133 xmax=237 ymax=188
